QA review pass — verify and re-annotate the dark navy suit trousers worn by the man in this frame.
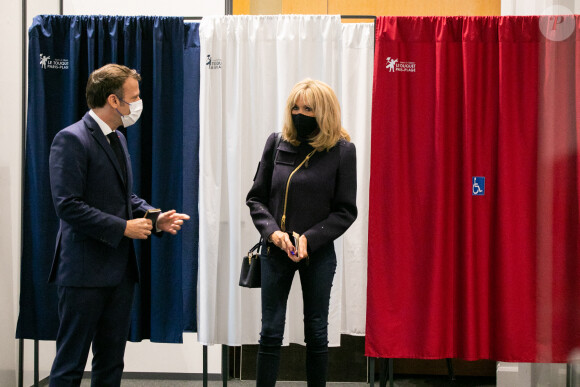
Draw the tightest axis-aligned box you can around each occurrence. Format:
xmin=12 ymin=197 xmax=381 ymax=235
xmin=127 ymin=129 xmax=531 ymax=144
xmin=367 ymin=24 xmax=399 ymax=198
xmin=50 ymin=273 xmax=135 ymax=387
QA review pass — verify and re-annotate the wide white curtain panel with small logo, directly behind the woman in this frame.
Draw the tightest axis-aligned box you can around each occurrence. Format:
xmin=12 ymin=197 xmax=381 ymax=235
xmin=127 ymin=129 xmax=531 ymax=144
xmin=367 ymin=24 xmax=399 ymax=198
xmin=198 ymin=15 xmax=342 ymax=345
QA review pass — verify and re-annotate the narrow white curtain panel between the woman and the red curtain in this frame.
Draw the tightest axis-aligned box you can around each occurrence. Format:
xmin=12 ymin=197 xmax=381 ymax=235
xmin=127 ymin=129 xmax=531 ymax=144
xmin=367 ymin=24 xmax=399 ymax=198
xmin=336 ymin=23 xmax=374 ymax=336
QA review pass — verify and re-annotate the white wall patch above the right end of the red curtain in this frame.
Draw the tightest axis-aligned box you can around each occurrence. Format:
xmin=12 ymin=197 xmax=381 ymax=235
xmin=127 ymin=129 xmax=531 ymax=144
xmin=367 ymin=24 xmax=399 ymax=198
xmin=501 ymin=0 xmax=580 ymax=16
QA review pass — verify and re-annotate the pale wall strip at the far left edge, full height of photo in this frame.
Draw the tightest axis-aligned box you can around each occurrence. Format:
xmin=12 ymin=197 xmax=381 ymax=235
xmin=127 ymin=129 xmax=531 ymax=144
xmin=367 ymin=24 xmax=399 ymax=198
xmin=0 ymin=0 xmax=22 ymax=386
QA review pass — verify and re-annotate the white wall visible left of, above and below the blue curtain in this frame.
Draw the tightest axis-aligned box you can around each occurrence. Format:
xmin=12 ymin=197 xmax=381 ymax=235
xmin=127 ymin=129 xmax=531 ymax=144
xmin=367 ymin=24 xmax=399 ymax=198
xmin=0 ymin=0 xmax=225 ymax=386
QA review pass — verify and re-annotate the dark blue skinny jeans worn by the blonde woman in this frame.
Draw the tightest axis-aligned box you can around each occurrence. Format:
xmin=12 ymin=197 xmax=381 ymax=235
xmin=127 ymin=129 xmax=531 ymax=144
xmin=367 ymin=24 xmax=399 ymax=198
xmin=256 ymin=243 xmax=336 ymax=387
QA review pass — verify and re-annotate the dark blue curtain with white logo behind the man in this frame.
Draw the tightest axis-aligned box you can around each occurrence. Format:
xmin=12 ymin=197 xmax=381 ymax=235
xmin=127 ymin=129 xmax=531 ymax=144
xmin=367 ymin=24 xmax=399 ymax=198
xmin=16 ymin=15 xmax=199 ymax=343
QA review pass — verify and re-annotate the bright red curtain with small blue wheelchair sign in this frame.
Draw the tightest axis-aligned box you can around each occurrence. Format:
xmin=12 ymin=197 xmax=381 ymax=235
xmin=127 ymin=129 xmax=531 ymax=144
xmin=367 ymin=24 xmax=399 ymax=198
xmin=366 ymin=16 xmax=580 ymax=362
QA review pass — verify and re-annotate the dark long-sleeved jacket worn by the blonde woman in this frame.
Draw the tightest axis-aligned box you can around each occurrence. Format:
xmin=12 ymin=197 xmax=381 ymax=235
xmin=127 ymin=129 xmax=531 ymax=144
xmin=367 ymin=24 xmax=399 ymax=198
xmin=246 ymin=133 xmax=357 ymax=253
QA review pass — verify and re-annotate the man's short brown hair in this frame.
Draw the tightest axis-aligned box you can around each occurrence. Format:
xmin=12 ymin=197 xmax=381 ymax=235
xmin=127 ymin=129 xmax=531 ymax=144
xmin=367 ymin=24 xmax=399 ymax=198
xmin=86 ymin=63 xmax=141 ymax=109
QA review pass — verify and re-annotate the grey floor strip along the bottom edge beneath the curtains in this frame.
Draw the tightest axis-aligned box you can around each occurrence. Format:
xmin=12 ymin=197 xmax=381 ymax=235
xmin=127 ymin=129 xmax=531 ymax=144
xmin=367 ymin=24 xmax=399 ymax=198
xmin=75 ymin=376 xmax=495 ymax=387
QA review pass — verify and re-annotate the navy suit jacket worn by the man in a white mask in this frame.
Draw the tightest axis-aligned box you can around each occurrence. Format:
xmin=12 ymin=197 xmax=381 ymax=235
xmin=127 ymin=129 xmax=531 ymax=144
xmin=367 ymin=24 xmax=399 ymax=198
xmin=49 ymin=112 xmax=152 ymax=287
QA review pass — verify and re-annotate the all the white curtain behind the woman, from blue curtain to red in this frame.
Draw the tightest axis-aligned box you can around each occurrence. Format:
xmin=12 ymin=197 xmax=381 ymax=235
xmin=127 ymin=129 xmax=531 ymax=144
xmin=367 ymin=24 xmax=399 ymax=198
xmin=199 ymin=16 xmax=373 ymax=346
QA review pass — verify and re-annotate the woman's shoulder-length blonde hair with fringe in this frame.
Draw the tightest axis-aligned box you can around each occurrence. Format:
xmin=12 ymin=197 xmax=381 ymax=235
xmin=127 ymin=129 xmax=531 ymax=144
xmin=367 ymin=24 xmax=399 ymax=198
xmin=282 ymin=78 xmax=350 ymax=151
